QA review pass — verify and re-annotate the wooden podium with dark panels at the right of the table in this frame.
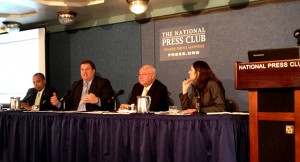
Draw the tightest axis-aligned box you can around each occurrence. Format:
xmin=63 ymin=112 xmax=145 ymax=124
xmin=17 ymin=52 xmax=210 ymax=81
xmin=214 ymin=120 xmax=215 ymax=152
xmin=234 ymin=59 xmax=300 ymax=162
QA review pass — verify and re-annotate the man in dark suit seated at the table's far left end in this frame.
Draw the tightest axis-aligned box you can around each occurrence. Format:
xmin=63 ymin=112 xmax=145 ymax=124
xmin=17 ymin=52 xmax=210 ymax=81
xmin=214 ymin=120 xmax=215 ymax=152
xmin=21 ymin=73 xmax=57 ymax=111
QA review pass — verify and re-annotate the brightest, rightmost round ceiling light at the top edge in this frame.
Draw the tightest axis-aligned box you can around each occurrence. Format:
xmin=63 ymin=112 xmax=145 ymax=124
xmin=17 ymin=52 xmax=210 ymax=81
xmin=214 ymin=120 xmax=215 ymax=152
xmin=126 ymin=0 xmax=149 ymax=14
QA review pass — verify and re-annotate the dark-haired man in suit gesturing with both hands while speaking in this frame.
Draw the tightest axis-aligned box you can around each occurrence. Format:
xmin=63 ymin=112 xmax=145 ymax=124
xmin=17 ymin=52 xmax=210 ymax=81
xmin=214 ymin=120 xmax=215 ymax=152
xmin=51 ymin=60 xmax=114 ymax=111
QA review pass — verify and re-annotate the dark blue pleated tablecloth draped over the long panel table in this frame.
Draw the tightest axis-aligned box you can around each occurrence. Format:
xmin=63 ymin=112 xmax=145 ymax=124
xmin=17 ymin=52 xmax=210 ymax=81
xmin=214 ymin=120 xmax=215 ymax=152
xmin=0 ymin=112 xmax=249 ymax=162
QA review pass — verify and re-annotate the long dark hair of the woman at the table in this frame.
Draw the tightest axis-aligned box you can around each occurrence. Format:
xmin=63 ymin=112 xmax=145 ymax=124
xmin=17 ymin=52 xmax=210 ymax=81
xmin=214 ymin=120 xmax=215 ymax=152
xmin=193 ymin=61 xmax=225 ymax=99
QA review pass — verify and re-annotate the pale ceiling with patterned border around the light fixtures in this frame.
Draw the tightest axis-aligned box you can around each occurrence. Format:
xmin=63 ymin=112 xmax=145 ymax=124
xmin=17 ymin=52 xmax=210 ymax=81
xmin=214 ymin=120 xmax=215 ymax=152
xmin=0 ymin=0 xmax=267 ymax=32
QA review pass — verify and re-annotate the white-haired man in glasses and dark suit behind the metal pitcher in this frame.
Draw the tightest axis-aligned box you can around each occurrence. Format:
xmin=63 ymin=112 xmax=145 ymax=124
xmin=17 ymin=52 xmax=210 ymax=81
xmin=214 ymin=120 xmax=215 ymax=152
xmin=119 ymin=65 xmax=169 ymax=111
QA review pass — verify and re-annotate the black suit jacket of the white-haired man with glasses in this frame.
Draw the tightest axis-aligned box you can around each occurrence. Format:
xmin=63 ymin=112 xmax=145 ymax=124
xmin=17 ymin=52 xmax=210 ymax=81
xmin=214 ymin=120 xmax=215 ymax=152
xmin=128 ymin=80 xmax=169 ymax=111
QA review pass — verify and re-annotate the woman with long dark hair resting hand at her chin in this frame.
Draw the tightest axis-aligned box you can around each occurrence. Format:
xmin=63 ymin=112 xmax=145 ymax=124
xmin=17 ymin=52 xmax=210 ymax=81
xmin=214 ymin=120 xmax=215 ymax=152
xmin=179 ymin=61 xmax=225 ymax=113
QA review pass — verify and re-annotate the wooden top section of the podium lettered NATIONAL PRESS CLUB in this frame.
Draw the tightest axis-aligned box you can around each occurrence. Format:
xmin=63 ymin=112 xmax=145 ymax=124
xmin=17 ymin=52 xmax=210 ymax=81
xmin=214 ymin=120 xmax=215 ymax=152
xmin=235 ymin=59 xmax=300 ymax=89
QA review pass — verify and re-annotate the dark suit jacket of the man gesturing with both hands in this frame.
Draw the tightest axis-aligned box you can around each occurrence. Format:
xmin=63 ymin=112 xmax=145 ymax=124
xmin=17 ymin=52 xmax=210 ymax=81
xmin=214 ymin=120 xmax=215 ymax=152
xmin=65 ymin=76 xmax=114 ymax=111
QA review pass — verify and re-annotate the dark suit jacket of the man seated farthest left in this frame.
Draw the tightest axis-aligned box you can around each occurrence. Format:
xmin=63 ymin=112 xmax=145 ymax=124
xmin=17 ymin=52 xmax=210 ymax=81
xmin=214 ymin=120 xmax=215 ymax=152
xmin=21 ymin=85 xmax=58 ymax=111
